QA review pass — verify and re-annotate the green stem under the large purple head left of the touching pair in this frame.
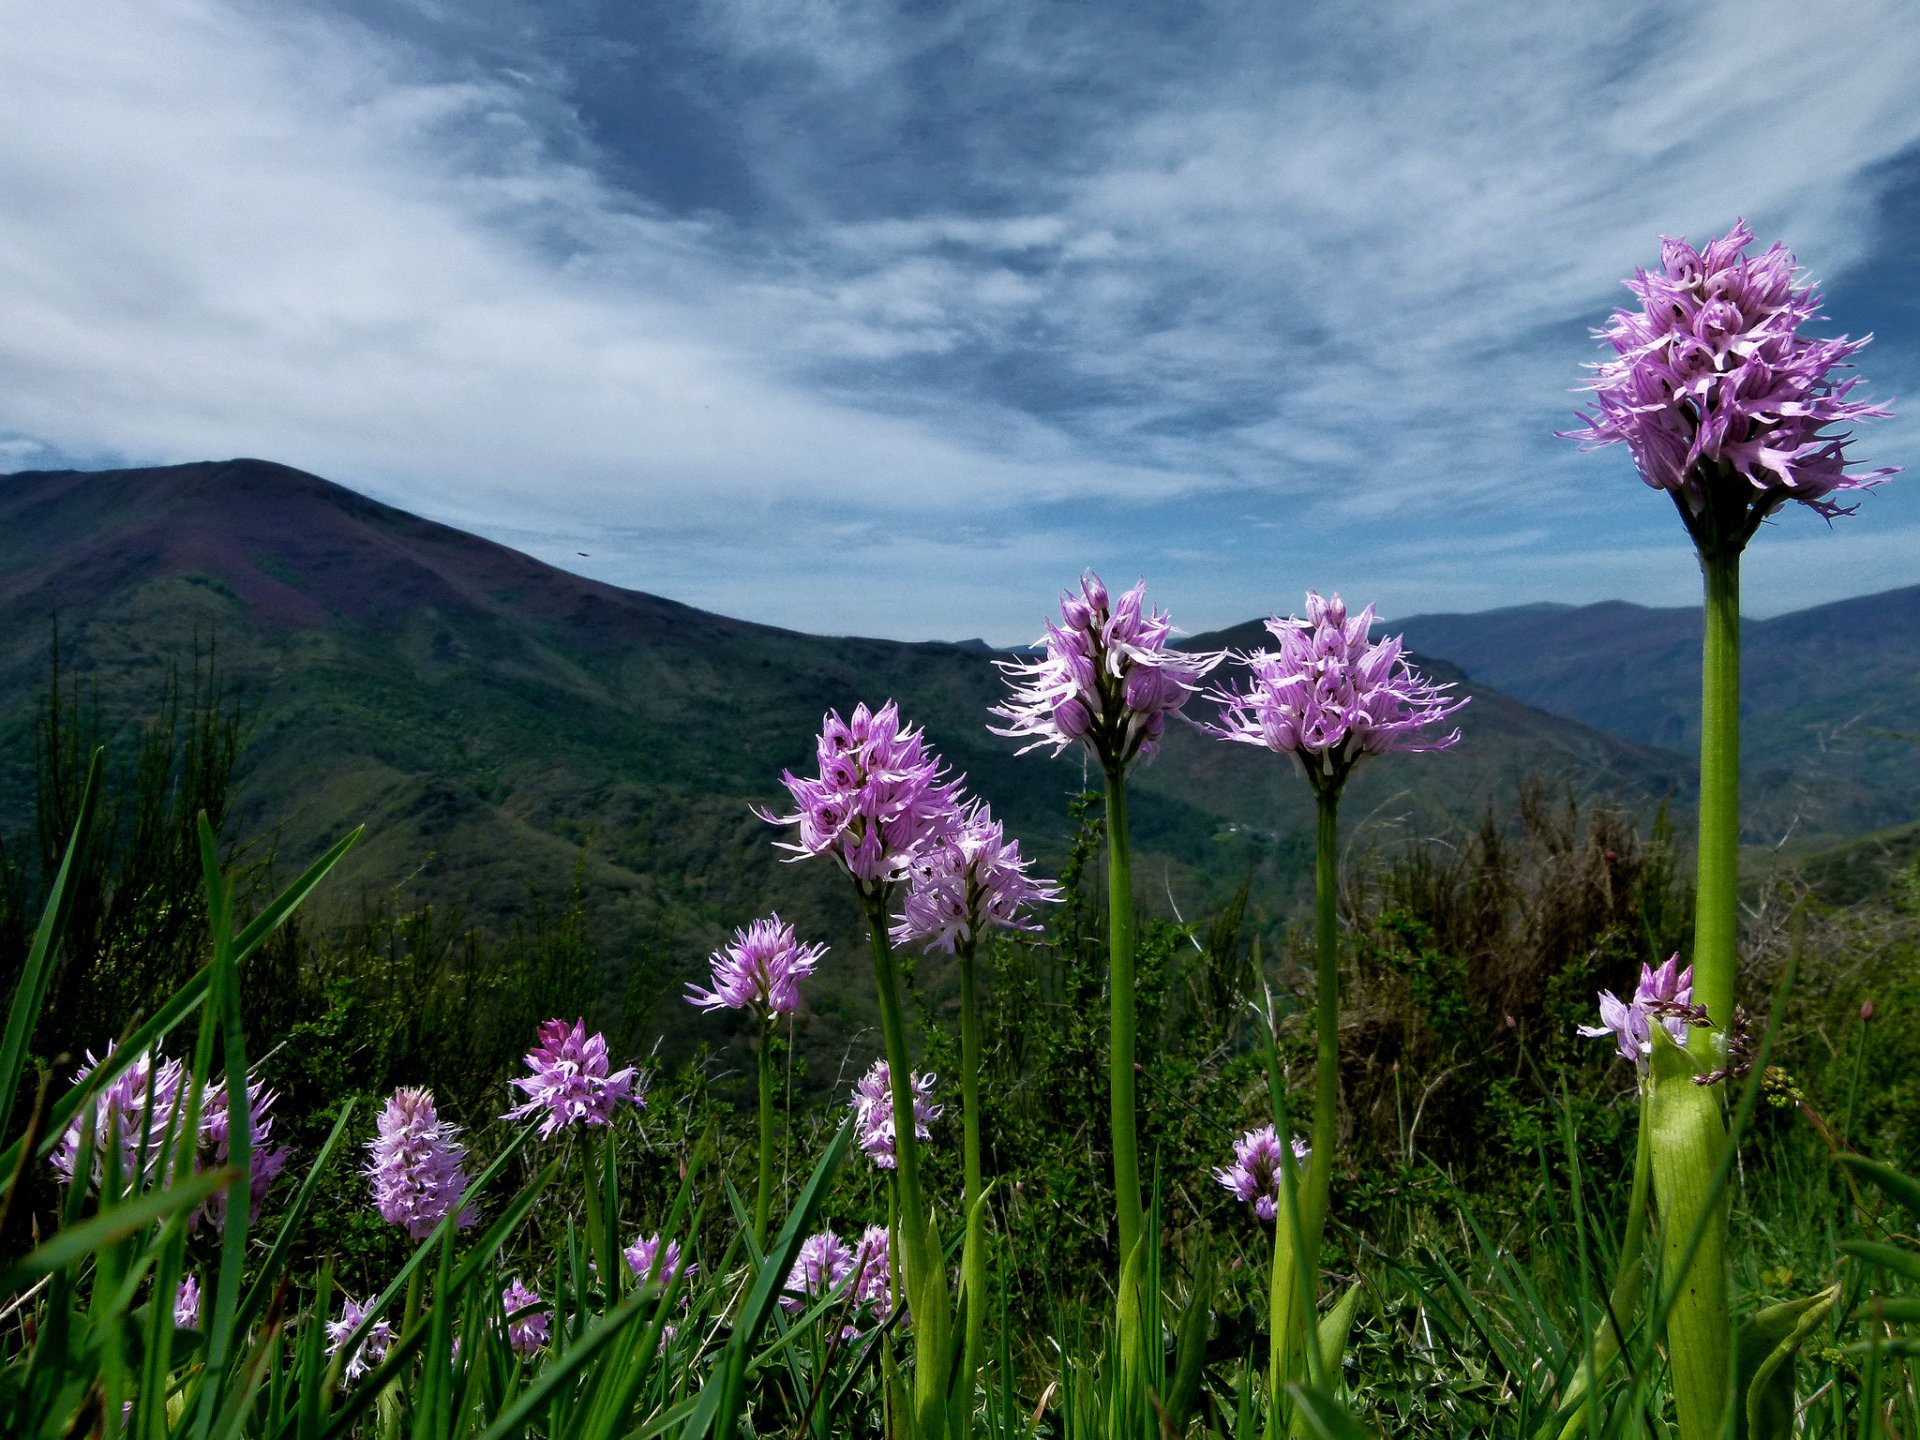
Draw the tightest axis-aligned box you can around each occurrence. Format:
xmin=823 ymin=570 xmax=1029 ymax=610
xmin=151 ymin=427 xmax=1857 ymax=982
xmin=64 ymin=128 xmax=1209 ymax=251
xmin=862 ymin=893 xmax=952 ymax=1440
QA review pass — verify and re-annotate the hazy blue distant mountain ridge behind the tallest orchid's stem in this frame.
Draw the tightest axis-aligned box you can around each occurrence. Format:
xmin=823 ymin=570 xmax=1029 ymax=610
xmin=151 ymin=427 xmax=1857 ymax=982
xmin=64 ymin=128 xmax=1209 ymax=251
xmin=1384 ymin=586 xmax=1920 ymax=843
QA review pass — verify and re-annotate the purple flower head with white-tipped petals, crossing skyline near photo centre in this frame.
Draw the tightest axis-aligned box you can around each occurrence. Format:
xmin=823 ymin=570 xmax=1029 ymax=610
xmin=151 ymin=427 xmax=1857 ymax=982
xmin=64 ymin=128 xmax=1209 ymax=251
xmin=989 ymin=570 xmax=1221 ymax=766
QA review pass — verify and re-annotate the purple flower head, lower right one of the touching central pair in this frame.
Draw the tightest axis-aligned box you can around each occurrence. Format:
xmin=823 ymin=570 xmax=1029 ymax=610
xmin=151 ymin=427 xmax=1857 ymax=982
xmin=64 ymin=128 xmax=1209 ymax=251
xmin=893 ymin=801 xmax=1060 ymax=950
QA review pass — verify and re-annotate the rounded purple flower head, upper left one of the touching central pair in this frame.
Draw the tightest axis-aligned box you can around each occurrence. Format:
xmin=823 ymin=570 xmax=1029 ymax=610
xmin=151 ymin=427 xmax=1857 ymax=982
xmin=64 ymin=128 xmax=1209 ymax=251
xmin=755 ymin=701 xmax=960 ymax=887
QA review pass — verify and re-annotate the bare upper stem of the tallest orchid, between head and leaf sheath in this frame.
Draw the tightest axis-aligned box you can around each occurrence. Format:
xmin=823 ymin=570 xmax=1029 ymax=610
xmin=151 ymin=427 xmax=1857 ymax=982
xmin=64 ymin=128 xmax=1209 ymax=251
xmin=1688 ymin=549 xmax=1740 ymax=1069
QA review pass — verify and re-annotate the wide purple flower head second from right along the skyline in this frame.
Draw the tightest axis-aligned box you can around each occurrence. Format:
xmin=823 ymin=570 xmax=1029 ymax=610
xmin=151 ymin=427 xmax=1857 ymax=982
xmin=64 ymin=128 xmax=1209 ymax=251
xmin=1202 ymin=589 xmax=1467 ymax=791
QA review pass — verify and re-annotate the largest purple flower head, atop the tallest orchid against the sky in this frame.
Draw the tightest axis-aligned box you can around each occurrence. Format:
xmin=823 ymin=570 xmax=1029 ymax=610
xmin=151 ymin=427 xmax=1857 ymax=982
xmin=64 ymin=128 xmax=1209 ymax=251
xmin=1565 ymin=221 xmax=1893 ymax=551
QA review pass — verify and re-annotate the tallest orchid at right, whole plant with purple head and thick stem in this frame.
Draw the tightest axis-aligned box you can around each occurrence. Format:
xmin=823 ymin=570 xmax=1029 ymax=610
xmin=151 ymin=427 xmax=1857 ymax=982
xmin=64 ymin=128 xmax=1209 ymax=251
xmin=1565 ymin=221 xmax=1893 ymax=1440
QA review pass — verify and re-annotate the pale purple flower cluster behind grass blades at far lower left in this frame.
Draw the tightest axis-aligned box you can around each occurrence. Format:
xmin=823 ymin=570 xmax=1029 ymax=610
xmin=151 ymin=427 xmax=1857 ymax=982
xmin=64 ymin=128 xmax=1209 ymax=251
xmin=52 ymin=1043 xmax=288 ymax=1229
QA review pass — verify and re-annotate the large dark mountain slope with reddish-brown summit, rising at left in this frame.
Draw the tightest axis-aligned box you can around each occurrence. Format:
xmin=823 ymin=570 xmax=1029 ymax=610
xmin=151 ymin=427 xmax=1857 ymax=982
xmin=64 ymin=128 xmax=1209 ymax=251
xmin=0 ymin=461 xmax=1688 ymax=1059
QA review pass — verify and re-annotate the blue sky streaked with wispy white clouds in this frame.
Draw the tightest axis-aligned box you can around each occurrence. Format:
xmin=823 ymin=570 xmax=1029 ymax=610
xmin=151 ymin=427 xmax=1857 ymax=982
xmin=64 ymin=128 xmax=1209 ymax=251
xmin=0 ymin=0 xmax=1920 ymax=643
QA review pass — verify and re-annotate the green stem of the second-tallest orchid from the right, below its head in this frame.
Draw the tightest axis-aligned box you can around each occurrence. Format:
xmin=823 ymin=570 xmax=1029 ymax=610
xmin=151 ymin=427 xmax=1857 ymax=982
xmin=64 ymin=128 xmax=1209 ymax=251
xmin=1267 ymin=783 xmax=1340 ymax=1394
